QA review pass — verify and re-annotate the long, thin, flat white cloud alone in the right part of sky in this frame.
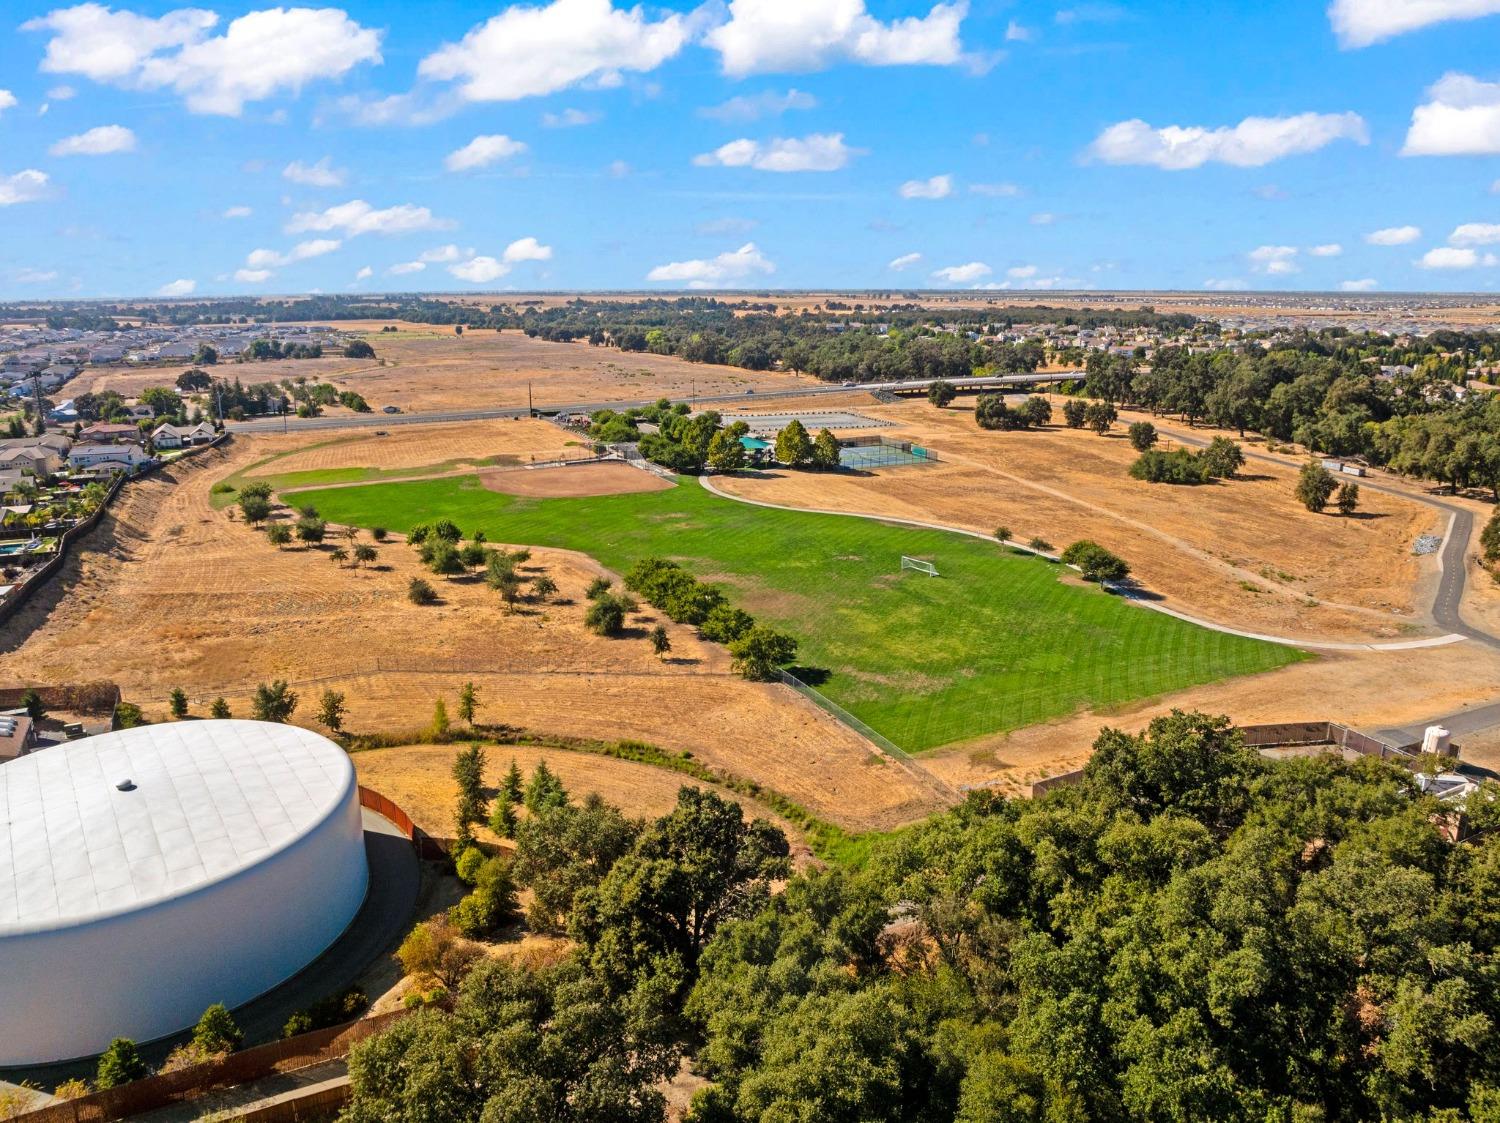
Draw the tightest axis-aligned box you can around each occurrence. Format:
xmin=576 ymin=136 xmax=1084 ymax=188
xmin=1088 ymin=112 xmax=1370 ymax=171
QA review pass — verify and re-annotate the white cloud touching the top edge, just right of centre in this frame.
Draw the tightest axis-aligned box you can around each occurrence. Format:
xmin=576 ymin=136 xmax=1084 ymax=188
xmin=704 ymin=0 xmax=968 ymax=78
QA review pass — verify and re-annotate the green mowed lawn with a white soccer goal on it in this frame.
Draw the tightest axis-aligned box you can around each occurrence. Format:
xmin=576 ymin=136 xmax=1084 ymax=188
xmin=291 ymin=478 xmax=1307 ymax=751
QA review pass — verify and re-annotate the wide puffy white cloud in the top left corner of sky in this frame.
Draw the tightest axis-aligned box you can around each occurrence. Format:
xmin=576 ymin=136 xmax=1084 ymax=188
xmin=21 ymin=3 xmax=381 ymax=117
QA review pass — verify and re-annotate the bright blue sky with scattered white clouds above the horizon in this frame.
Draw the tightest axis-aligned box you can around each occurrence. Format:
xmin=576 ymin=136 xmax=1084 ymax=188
xmin=0 ymin=0 xmax=1500 ymax=298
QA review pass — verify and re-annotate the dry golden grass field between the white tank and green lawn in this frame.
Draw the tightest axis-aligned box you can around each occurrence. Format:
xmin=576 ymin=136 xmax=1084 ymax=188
xmin=0 ymin=438 xmax=944 ymax=829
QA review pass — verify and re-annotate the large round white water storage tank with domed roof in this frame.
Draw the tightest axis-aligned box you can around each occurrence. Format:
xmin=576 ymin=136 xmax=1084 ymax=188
xmin=0 ymin=721 xmax=369 ymax=1066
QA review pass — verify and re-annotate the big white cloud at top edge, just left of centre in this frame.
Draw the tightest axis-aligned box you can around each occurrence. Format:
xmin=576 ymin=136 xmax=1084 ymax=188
xmin=417 ymin=0 xmax=690 ymax=102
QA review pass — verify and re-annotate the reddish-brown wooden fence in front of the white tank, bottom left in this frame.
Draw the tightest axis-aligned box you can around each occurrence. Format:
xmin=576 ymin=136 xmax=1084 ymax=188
xmin=15 ymin=1009 xmax=411 ymax=1123
